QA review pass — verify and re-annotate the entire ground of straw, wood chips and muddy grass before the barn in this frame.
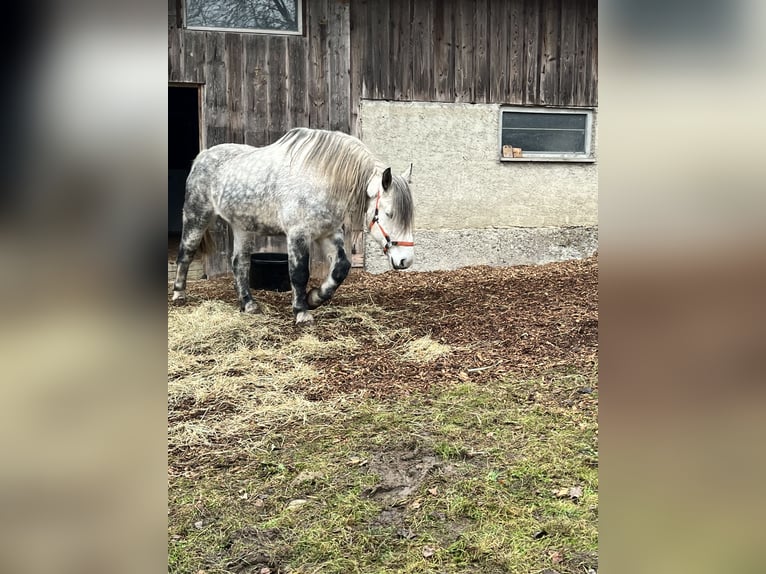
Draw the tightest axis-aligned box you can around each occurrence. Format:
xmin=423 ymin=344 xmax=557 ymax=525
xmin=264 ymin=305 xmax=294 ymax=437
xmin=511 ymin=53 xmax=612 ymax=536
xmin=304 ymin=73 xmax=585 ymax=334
xmin=168 ymin=257 xmax=598 ymax=574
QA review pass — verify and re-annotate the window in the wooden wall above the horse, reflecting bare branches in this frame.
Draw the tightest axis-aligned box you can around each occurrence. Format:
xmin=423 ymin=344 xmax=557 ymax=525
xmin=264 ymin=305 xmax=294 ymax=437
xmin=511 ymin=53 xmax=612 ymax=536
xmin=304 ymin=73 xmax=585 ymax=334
xmin=185 ymin=0 xmax=303 ymax=34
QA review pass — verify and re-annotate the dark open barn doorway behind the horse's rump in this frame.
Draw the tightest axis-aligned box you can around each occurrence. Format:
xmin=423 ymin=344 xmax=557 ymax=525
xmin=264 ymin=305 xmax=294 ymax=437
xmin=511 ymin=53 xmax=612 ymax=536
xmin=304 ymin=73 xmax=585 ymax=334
xmin=168 ymin=86 xmax=200 ymax=241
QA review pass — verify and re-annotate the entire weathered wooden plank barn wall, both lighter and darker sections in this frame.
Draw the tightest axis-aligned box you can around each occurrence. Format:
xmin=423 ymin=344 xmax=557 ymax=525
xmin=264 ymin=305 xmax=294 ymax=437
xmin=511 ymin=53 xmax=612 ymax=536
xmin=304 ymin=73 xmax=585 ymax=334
xmin=168 ymin=0 xmax=598 ymax=275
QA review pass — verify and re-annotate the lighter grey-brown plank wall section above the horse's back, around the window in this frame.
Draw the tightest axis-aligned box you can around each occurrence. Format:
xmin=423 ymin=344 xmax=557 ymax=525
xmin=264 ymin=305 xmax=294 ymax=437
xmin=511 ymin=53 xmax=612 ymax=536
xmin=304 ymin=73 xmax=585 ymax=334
xmin=168 ymin=0 xmax=351 ymax=147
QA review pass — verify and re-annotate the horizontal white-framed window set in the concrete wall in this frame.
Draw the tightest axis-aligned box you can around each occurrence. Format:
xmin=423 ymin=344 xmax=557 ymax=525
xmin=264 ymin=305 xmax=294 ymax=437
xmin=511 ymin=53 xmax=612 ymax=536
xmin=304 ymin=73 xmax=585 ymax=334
xmin=500 ymin=108 xmax=594 ymax=161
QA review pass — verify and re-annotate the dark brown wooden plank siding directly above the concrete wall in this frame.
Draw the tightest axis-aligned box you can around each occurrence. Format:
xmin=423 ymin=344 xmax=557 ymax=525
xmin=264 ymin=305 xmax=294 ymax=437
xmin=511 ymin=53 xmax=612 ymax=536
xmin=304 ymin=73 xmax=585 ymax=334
xmin=351 ymin=0 xmax=598 ymax=108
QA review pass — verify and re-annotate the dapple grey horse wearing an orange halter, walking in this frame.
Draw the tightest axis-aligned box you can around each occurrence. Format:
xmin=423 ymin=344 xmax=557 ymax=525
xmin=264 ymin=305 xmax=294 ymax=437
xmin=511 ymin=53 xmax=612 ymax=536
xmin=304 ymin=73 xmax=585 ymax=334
xmin=173 ymin=128 xmax=414 ymax=324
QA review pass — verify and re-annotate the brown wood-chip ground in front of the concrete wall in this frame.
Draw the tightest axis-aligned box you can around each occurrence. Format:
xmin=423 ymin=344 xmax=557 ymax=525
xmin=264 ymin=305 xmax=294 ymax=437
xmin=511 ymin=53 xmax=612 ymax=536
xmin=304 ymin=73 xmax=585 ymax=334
xmin=188 ymin=256 xmax=598 ymax=400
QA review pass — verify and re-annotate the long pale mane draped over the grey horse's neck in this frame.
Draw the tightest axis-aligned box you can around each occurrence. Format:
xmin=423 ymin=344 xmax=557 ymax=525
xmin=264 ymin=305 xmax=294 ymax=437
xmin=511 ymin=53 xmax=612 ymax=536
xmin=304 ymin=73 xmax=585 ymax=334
xmin=275 ymin=128 xmax=383 ymax=225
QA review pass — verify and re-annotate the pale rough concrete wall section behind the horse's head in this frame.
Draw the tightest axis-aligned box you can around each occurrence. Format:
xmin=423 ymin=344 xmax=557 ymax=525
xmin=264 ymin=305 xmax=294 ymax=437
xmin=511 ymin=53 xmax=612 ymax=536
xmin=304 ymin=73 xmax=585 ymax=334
xmin=360 ymin=100 xmax=598 ymax=272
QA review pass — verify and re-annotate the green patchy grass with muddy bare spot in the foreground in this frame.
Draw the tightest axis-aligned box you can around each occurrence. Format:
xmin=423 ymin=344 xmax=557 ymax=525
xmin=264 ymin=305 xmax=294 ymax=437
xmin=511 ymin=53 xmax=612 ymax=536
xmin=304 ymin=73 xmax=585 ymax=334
xmin=169 ymin=379 xmax=598 ymax=574
